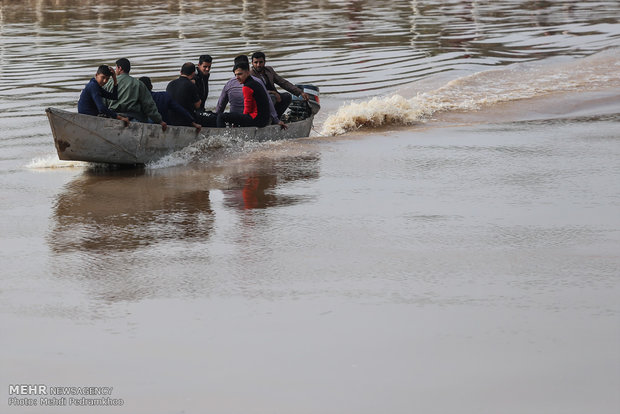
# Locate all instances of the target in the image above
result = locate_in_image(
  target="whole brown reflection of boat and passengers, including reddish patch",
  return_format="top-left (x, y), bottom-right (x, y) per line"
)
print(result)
top-left (48, 154), bottom-right (318, 254)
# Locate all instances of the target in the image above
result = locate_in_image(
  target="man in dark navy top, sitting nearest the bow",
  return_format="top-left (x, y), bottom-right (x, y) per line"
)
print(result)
top-left (78, 65), bottom-right (129, 125)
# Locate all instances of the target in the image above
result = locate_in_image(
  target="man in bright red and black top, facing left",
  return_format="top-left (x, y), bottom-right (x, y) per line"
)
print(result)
top-left (217, 62), bottom-right (271, 128)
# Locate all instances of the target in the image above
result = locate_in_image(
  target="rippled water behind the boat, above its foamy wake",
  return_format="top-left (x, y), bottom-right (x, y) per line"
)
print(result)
top-left (0, 0), bottom-right (620, 151)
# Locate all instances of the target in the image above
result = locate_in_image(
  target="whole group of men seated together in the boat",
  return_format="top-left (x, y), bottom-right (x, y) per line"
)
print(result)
top-left (78, 52), bottom-right (308, 131)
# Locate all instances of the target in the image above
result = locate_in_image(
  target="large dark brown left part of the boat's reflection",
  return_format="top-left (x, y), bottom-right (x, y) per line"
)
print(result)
top-left (49, 170), bottom-right (214, 252)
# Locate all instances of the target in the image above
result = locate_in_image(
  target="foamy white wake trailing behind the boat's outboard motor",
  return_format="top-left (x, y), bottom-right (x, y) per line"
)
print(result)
top-left (321, 48), bottom-right (620, 135)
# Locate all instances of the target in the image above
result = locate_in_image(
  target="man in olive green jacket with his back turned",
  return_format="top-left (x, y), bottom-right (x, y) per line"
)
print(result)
top-left (106, 58), bottom-right (167, 131)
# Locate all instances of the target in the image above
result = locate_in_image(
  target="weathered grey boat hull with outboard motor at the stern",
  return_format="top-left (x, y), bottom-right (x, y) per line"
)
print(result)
top-left (45, 85), bottom-right (320, 165)
